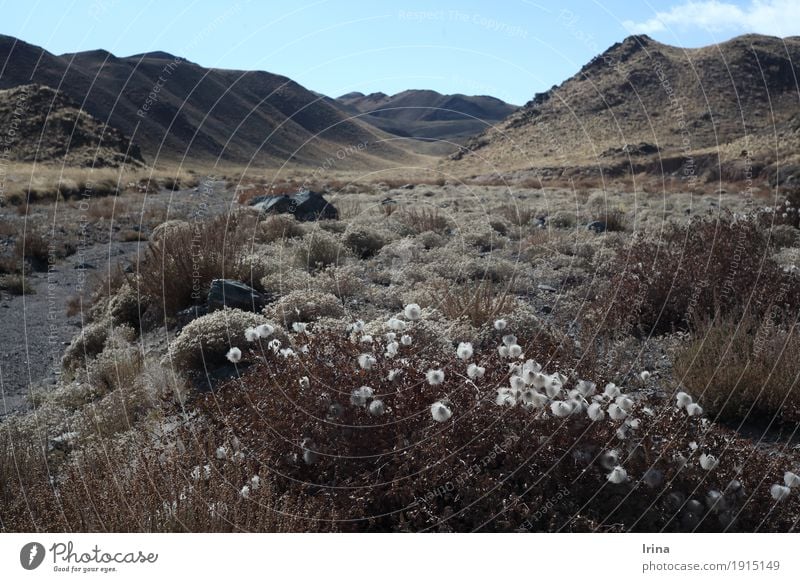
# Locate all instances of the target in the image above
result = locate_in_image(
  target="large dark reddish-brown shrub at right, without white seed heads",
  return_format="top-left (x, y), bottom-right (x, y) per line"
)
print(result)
top-left (588, 216), bottom-right (800, 335)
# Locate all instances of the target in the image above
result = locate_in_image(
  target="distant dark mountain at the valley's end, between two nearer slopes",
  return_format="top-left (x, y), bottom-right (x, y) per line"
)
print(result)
top-left (337, 90), bottom-right (517, 143)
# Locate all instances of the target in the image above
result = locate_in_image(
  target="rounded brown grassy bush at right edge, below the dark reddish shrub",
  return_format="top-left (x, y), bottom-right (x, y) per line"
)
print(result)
top-left (675, 314), bottom-right (800, 423)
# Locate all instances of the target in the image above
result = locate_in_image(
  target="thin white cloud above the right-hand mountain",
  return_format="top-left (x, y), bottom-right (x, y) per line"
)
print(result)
top-left (623, 0), bottom-right (800, 36)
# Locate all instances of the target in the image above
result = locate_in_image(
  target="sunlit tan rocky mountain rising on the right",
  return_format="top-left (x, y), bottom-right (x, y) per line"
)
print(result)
top-left (449, 34), bottom-right (800, 181)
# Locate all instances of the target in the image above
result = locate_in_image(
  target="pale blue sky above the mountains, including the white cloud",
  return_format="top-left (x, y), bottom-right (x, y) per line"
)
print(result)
top-left (0, 0), bottom-right (800, 105)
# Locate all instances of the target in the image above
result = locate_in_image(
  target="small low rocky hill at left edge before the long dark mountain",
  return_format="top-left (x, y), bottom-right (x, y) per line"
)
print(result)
top-left (0, 84), bottom-right (143, 167)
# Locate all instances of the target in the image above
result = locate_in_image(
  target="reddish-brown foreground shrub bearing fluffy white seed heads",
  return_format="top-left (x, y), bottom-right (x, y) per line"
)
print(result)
top-left (186, 326), bottom-right (800, 532)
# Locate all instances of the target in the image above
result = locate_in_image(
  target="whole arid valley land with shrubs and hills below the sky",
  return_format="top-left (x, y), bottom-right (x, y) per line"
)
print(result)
top-left (0, 30), bottom-right (800, 532)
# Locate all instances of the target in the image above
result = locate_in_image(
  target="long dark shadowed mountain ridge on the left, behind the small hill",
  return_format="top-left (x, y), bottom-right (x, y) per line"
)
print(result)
top-left (0, 36), bottom-right (418, 168)
